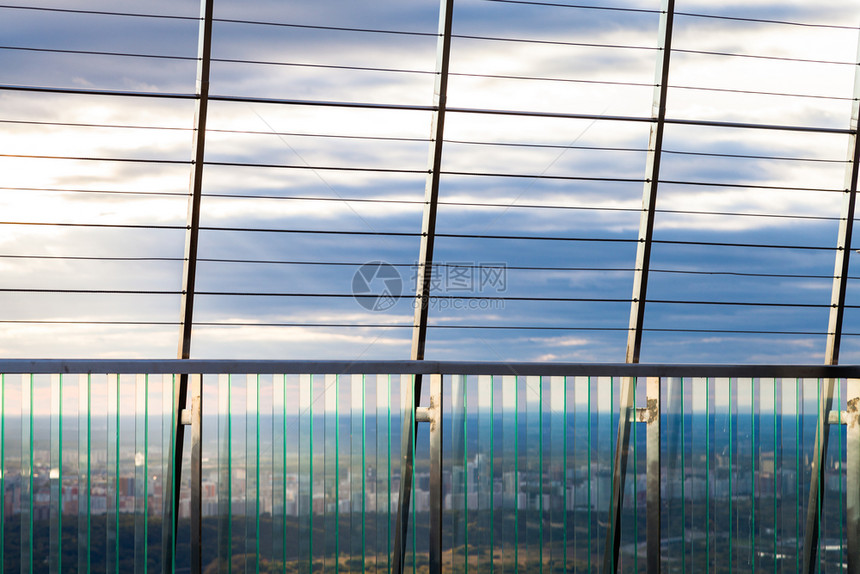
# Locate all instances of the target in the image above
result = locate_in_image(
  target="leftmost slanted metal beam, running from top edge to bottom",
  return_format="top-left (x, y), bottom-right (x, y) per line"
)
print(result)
top-left (162, 0), bottom-right (214, 574)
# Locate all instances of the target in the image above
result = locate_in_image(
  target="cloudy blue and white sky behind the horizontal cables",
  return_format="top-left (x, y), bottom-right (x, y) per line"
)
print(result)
top-left (0, 0), bottom-right (860, 363)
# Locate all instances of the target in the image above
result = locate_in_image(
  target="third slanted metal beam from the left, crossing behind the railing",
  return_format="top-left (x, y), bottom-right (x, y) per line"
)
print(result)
top-left (603, 0), bottom-right (675, 573)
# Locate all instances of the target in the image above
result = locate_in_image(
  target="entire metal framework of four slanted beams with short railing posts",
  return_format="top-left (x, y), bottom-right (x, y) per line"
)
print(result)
top-left (131, 0), bottom-right (860, 574)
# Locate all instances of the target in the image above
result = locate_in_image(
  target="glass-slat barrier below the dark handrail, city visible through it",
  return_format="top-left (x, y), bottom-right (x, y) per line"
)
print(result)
top-left (0, 374), bottom-right (848, 574)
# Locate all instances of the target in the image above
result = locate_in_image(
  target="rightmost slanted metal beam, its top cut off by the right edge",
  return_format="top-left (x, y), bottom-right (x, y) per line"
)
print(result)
top-left (803, 27), bottom-right (860, 573)
